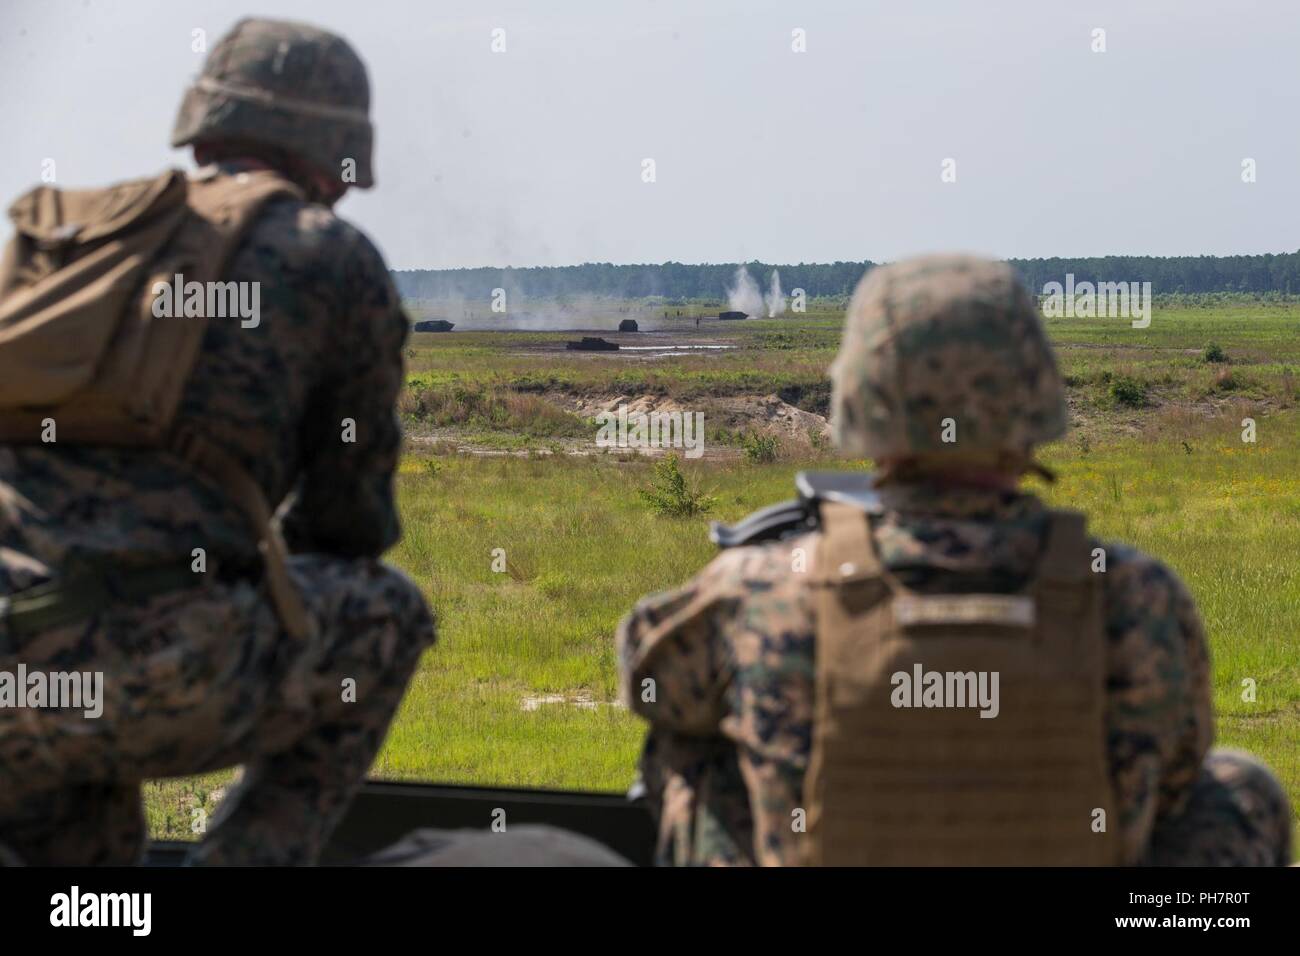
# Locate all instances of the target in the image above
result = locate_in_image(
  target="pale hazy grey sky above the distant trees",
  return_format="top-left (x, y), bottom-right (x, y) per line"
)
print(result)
top-left (0, 0), bottom-right (1300, 268)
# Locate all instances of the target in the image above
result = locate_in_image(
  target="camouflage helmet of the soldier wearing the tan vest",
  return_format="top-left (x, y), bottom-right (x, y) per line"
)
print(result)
top-left (831, 255), bottom-right (1066, 472)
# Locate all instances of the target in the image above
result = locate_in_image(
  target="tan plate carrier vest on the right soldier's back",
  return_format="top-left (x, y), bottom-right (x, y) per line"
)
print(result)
top-left (805, 502), bottom-right (1121, 866)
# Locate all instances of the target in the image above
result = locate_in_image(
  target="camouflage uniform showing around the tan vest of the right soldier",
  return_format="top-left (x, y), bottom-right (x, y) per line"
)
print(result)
top-left (618, 485), bottom-right (1290, 865)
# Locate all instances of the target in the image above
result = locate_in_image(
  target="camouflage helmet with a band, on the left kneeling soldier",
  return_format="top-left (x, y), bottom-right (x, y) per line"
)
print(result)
top-left (172, 18), bottom-right (374, 189)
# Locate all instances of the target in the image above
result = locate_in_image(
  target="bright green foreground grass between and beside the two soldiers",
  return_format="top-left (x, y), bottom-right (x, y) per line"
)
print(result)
top-left (378, 416), bottom-right (1300, 796)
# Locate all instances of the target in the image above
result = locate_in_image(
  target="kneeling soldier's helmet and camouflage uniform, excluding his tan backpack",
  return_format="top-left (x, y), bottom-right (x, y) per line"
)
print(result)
top-left (0, 20), bottom-right (434, 864)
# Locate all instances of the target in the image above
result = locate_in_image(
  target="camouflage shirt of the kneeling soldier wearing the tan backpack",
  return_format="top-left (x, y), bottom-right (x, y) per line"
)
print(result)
top-left (0, 164), bottom-right (408, 593)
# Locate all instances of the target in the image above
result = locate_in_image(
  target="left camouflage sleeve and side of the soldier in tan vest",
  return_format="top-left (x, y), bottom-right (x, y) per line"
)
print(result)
top-left (618, 536), bottom-right (814, 866)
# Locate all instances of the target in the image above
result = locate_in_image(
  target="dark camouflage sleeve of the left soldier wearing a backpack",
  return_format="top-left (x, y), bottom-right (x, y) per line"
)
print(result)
top-left (283, 233), bottom-right (411, 557)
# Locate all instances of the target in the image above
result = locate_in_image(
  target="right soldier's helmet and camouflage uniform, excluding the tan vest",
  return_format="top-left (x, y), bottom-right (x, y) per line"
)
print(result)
top-left (618, 258), bottom-right (1291, 865)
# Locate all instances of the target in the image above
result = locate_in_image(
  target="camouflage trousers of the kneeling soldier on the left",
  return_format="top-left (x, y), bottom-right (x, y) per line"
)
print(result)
top-left (0, 554), bottom-right (432, 865)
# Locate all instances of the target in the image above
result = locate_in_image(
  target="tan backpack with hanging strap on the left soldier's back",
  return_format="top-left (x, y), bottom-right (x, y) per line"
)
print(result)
top-left (0, 168), bottom-right (311, 639)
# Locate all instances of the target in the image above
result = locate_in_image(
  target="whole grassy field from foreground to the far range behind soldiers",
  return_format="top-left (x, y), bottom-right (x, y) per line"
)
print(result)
top-left (148, 304), bottom-right (1300, 853)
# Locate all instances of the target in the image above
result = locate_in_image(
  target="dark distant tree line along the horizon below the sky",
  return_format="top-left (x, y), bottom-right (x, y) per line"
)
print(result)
top-left (393, 251), bottom-right (1300, 300)
